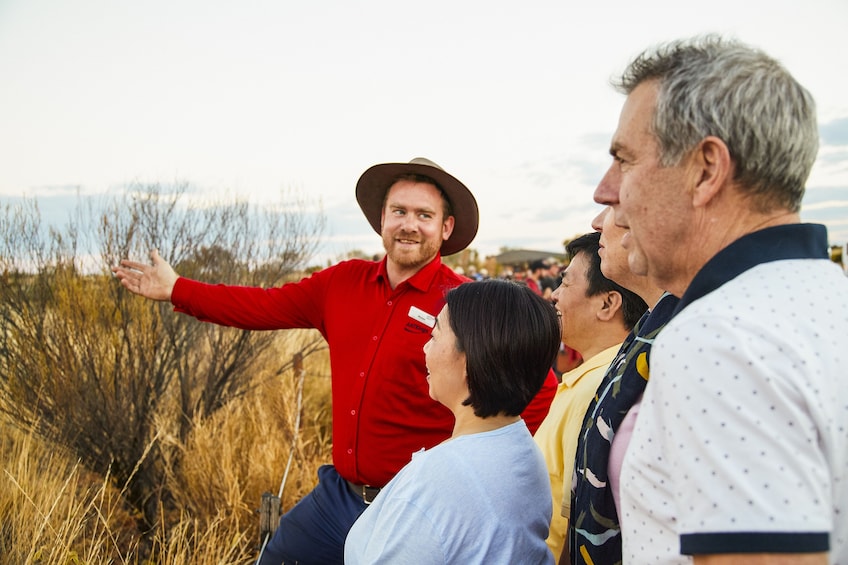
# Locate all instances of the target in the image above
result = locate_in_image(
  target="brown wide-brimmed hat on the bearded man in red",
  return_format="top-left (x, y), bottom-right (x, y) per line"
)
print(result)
top-left (356, 157), bottom-right (480, 255)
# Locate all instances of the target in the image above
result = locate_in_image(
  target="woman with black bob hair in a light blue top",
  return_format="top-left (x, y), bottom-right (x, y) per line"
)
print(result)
top-left (345, 279), bottom-right (560, 564)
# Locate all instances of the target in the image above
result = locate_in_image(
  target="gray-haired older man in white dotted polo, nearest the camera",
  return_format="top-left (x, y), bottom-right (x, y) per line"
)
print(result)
top-left (595, 36), bottom-right (848, 564)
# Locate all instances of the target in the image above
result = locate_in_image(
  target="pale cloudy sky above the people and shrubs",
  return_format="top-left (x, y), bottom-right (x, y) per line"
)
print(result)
top-left (0, 0), bottom-right (848, 257)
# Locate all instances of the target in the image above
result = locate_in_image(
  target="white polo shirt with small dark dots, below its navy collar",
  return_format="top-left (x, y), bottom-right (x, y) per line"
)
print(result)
top-left (621, 226), bottom-right (848, 564)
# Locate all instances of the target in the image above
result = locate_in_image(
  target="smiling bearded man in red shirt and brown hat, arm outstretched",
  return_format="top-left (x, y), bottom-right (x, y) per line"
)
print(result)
top-left (113, 158), bottom-right (557, 565)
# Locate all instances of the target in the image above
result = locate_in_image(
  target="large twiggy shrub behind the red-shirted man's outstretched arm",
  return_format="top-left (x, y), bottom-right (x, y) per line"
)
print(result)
top-left (0, 185), bottom-right (324, 528)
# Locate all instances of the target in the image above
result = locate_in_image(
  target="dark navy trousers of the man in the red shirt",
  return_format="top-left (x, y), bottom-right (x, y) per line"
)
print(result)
top-left (255, 465), bottom-right (366, 565)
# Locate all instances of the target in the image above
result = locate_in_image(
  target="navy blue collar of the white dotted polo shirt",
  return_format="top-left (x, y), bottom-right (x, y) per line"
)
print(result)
top-left (674, 224), bottom-right (828, 314)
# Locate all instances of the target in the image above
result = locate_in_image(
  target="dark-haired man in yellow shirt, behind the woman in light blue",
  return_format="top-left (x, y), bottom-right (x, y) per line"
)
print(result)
top-left (534, 232), bottom-right (648, 560)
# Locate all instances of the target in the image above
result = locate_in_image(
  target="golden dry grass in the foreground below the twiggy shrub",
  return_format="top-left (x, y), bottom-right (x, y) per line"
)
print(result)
top-left (0, 334), bottom-right (331, 565)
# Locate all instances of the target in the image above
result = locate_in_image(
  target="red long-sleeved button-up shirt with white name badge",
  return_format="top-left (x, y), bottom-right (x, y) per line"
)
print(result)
top-left (171, 256), bottom-right (557, 486)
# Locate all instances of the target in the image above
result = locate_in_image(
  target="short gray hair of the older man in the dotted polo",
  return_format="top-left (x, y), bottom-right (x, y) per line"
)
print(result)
top-left (613, 35), bottom-right (819, 212)
